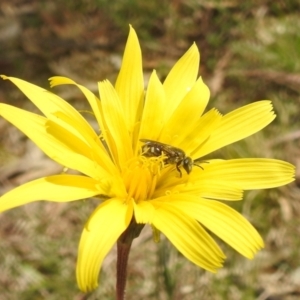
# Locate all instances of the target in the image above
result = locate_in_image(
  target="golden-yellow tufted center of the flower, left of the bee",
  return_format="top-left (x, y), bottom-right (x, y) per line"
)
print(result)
top-left (122, 156), bottom-right (163, 202)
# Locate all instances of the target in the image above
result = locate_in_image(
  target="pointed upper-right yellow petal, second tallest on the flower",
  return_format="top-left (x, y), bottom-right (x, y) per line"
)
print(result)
top-left (163, 44), bottom-right (200, 122)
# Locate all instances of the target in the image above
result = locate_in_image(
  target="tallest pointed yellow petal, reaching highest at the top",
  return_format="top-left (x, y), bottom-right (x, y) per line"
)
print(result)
top-left (115, 26), bottom-right (144, 135)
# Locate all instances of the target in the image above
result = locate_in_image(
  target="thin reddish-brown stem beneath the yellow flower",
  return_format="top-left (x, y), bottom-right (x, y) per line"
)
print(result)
top-left (116, 218), bottom-right (145, 300)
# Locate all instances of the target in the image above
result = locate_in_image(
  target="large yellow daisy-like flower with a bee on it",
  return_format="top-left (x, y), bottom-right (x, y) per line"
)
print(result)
top-left (0, 28), bottom-right (294, 291)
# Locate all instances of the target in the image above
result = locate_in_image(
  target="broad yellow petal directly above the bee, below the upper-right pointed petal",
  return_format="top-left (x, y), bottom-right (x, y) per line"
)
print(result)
top-left (160, 77), bottom-right (210, 145)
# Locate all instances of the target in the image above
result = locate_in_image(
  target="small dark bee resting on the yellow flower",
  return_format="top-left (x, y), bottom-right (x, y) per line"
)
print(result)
top-left (140, 139), bottom-right (203, 177)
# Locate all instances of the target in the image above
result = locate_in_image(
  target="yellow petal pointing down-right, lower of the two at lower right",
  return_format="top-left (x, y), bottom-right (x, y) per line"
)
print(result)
top-left (151, 200), bottom-right (225, 272)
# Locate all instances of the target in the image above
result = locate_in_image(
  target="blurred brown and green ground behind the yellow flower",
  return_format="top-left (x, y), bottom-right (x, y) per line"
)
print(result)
top-left (0, 0), bottom-right (300, 300)
